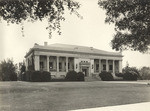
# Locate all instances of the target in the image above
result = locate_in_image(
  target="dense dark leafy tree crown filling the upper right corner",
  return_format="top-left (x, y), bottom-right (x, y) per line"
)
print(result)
top-left (98, 0), bottom-right (150, 53)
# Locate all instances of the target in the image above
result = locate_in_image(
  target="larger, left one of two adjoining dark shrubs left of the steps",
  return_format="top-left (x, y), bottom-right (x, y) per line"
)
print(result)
top-left (65, 71), bottom-right (77, 81)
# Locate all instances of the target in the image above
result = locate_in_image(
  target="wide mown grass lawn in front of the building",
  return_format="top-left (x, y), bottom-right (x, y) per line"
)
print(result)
top-left (0, 81), bottom-right (150, 111)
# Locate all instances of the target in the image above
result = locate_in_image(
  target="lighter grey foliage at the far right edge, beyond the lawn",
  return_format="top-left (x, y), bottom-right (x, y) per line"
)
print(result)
top-left (139, 67), bottom-right (150, 80)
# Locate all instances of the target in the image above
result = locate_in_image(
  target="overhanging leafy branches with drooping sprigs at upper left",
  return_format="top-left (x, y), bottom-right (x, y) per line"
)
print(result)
top-left (0, 0), bottom-right (80, 37)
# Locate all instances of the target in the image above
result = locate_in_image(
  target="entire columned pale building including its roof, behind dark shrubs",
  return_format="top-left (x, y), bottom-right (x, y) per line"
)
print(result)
top-left (25, 42), bottom-right (123, 78)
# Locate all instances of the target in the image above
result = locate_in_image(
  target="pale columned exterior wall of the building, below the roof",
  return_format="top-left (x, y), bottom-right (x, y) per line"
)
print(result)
top-left (26, 51), bottom-right (122, 78)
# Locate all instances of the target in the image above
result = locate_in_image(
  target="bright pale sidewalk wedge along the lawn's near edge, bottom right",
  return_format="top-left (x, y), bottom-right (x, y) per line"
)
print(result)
top-left (70, 102), bottom-right (150, 111)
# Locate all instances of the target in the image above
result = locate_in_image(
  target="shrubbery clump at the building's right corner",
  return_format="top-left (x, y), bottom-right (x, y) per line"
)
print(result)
top-left (123, 66), bottom-right (140, 80)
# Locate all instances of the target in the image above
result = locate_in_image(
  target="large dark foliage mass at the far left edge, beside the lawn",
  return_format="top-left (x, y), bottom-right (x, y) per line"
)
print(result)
top-left (0, 59), bottom-right (17, 81)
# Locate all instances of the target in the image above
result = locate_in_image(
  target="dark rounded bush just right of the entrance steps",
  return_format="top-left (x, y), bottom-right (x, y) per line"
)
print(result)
top-left (99, 72), bottom-right (114, 81)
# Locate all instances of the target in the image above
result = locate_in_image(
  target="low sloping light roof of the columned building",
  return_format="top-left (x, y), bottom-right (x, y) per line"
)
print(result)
top-left (25, 43), bottom-right (122, 57)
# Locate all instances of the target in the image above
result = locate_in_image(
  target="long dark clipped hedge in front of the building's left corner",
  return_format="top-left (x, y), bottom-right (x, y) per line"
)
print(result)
top-left (22, 71), bottom-right (51, 82)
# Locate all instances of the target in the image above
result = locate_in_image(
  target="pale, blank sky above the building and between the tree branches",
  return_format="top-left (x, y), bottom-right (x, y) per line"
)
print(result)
top-left (0, 0), bottom-right (150, 68)
